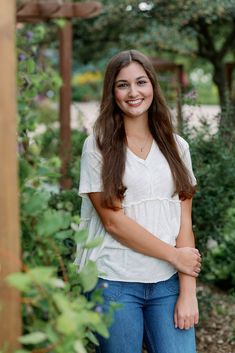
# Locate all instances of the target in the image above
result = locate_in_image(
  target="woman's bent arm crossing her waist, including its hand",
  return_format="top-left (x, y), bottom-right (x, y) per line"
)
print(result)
top-left (89, 192), bottom-right (201, 277)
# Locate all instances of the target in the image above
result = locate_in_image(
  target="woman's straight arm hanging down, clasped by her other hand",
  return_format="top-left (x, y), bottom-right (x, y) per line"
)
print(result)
top-left (174, 199), bottom-right (199, 329)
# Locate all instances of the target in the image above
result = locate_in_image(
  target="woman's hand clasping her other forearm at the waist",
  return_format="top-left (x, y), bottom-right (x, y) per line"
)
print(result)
top-left (172, 247), bottom-right (201, 277)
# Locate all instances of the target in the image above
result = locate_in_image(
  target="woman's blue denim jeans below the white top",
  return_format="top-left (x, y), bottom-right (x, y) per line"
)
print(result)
top-left (90, 274), bottom-right (196, 353)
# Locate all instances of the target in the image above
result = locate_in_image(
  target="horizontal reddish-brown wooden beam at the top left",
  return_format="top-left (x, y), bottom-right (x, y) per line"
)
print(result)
top-left (17, 1), bottom-right (102, 22)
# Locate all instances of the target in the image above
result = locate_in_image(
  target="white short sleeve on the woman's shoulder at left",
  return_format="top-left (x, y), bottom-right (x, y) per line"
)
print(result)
top-left (79, 136), bottom-right (103, 197)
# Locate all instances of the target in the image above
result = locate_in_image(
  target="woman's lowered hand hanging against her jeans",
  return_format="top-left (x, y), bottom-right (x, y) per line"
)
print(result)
top-left (174, 293), bottom-right (199, 330)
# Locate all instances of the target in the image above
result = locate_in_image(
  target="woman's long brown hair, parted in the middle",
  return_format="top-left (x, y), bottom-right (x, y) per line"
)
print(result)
top-left (94, 50), bottom-right (195, 209)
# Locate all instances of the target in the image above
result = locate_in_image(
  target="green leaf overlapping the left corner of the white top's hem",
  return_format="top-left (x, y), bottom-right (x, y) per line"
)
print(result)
top-left (79, 260), bottom-right (98, 292)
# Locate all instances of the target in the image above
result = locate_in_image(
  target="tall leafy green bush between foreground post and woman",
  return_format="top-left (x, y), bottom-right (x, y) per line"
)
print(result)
top-left (5, 24), bottom-right (114, 353)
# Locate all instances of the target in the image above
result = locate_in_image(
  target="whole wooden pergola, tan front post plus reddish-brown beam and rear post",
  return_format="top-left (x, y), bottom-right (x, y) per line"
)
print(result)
top-left (0, 0), bottom-right (101, 352)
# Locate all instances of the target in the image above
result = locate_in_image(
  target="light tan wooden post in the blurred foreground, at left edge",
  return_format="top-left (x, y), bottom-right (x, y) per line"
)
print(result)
top-left (0, 0), bottom-right (21, 352)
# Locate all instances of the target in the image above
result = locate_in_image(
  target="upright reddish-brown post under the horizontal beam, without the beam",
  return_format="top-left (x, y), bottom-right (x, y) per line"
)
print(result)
top-left (59, 21), bottom-right (72, 189)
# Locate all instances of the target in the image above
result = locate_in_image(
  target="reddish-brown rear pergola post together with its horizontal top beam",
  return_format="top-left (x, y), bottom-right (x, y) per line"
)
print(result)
top-left (17, 0), bottom-right (102, 189)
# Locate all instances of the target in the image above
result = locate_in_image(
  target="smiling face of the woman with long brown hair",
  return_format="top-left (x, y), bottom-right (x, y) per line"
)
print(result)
top-left (114, 62), bottom-right (153, 117)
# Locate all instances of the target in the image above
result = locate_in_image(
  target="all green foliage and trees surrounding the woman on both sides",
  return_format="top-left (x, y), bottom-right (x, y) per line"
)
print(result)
top-left (10, 0), bottom-right (235, 353)
